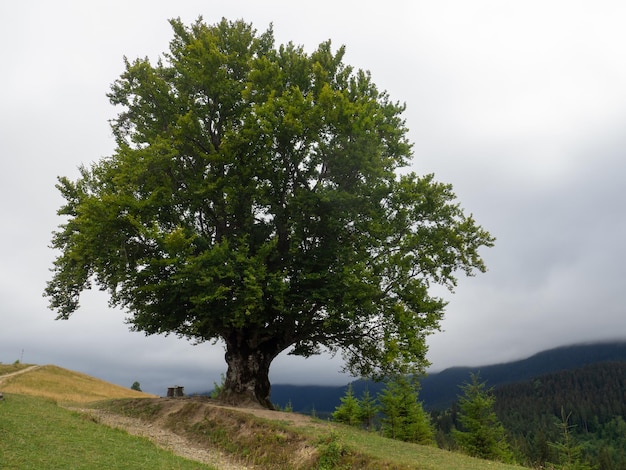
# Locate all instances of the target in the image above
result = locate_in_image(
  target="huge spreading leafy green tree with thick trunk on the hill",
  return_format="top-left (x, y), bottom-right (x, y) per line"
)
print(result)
top-left (45, 19), bottom-right (493, 407)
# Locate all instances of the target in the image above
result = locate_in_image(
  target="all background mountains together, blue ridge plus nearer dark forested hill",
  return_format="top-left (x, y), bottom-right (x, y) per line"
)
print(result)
top-left (272, 342), bottom-right (626, 470)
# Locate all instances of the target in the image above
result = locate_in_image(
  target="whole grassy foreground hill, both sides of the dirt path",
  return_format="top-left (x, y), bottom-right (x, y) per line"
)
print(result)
top-left (0, 366), bottom-right (521, 470)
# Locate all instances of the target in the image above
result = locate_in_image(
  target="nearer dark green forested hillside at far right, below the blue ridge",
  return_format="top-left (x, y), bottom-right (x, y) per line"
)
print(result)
top-left (433, 361), bottom-right (626, 470)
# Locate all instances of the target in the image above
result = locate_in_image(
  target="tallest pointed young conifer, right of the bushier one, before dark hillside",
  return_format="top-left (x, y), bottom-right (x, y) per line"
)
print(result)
top-left (452, 374), bottom-right (513, 462)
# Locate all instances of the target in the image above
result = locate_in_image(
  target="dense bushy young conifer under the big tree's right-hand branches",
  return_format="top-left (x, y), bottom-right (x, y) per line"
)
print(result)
top-left (379, 375), bottom-right (434, 444)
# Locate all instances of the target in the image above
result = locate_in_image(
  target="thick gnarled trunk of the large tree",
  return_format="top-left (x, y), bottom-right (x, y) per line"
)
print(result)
top-left (220, 333), bottom-right (282, 409)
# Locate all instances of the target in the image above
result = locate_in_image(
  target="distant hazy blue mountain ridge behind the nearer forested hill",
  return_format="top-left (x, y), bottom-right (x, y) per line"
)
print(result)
top-left (271, 341), bottom-right (626, 414)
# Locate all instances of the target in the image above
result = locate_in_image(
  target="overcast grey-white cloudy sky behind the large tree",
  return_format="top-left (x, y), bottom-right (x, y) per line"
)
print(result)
top-left (0, 0), bottom-right (626, 394)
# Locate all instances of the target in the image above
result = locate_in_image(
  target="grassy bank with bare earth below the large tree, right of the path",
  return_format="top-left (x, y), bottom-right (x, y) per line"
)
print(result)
top-left (94, 396), bottom-right (523, 470)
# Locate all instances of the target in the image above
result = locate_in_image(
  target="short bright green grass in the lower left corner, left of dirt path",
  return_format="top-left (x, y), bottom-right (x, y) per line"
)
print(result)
top-left (0, 394), bottom-right (211, 470)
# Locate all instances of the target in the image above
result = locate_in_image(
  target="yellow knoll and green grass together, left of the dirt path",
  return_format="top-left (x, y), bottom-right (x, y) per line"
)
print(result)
top-left (0, 364), bottom-right (214, 470)
